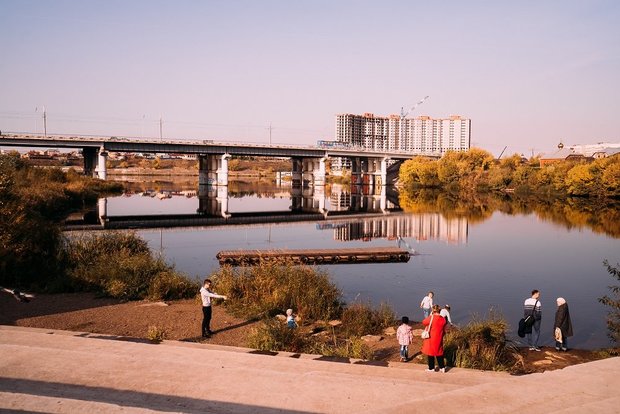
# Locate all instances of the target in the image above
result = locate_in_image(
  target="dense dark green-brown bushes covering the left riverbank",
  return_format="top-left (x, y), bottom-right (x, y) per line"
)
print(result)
top-left (0, 153), bottom-right (198, 299)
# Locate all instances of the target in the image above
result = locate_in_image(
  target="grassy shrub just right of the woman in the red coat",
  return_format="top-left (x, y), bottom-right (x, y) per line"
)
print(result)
top-left (444, 310), bottom-right (522, 371)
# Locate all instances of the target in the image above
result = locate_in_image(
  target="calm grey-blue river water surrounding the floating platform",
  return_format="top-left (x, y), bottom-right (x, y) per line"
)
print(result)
top-left (101, 183), bottom-right (620, 348)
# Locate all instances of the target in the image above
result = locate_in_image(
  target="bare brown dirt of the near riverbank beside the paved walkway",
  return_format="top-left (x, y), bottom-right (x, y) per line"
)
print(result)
top-left (0, 293), bottom-right (602, 373)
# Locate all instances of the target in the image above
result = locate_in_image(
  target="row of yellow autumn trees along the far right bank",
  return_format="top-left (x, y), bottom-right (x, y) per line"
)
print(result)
top-left (399, 148), bottom-right (620, 198)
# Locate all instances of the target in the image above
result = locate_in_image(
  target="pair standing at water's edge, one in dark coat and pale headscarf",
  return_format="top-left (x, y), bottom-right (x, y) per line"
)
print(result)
top-left (523, 289), bottom-right (573, 352)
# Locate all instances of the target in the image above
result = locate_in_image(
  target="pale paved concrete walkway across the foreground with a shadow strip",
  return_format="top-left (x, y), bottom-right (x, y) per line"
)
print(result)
top-left (0, 326), bottom-right (620, 414)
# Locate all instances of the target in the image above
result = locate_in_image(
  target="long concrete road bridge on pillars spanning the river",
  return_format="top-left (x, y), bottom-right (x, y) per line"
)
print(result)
top-left (0, 133), bottom-right (440, 186)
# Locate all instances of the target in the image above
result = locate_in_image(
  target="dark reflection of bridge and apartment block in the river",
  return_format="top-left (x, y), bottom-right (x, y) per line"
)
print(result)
top-left (65, 186), bottom-right (468, 244)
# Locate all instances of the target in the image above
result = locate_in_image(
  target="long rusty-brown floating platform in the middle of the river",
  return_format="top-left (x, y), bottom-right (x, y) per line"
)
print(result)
top-left (216, 247), bottom-right (410, 266)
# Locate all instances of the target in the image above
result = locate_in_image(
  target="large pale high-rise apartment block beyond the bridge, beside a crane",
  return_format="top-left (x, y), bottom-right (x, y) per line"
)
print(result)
top-left (336, 113), bottom-right (471, 155)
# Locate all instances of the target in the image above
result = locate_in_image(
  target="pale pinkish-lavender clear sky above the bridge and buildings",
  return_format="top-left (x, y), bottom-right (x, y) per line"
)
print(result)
top-left (0, 0), bottom-right (620, 156)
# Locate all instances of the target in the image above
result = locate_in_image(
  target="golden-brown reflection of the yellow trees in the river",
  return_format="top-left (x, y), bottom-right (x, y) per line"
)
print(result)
top-left (400, 190), bottom-right (620, 238)
